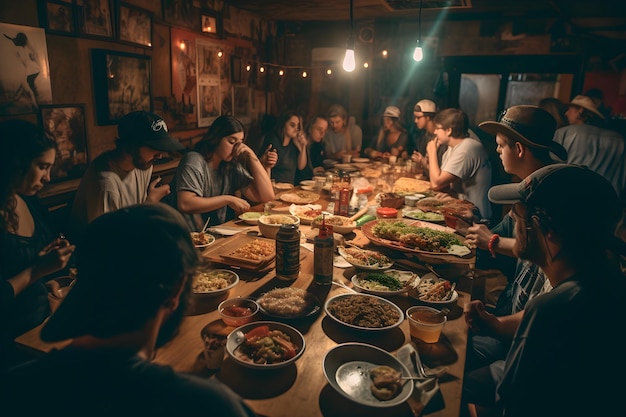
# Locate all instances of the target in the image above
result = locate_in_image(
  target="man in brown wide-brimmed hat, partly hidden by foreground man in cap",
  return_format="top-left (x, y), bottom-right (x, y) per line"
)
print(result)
top-left (463, 105), bottom-right (567, 416)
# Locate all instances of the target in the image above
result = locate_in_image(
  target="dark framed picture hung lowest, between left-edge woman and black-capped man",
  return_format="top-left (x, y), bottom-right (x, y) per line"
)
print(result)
top-left (39, 104), bottom-right (88, 182)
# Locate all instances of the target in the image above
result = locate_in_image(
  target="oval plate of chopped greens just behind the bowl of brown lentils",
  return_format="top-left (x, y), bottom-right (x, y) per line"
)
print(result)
top-left (352, 269), bottom-right (419, 297)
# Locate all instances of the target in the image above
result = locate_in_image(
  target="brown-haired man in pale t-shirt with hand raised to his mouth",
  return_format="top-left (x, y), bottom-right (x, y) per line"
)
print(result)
top-left (426, 108), bottom-right (491, 219)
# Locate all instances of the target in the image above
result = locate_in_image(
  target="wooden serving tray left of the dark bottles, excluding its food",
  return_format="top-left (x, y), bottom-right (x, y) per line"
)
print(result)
top-left (202, 234), bottom-right (276, 270)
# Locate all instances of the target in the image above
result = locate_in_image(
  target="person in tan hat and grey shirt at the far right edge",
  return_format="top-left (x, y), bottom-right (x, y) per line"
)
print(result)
top-left (554, 95), bottom-right (626, 199)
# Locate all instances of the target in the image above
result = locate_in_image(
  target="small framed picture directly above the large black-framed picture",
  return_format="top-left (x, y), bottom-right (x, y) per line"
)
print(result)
top-left (117, 3), bottom-right (152, 48)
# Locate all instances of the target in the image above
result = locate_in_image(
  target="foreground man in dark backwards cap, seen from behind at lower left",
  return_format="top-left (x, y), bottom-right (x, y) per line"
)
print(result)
top-left (0, 203), bottom-right (254, 417)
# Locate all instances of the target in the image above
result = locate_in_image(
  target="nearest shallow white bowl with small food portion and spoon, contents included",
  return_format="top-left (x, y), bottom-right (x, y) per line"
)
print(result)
top-left (322, 343), bottom-right (414, 408)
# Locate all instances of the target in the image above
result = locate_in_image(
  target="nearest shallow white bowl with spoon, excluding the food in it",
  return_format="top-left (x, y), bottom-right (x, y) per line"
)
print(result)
top-left (322, 343), bottom-right (414, 408)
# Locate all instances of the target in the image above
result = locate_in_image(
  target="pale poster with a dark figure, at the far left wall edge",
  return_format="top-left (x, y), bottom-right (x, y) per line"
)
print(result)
top-left (0, 23), bottom-right (52, 116)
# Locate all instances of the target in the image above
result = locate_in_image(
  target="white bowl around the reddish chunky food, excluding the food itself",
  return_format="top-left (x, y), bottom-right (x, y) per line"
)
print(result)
top-left (226, 321), bottom-right (306, 370)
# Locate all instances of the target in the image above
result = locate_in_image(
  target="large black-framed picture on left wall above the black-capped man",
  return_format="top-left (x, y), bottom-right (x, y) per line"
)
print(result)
top-left (91, 49), bottom-right (152, 125)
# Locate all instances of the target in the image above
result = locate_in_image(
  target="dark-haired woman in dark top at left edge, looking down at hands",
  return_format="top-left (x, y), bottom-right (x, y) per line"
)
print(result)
top-left (0, 120), bottom-right (74, 365)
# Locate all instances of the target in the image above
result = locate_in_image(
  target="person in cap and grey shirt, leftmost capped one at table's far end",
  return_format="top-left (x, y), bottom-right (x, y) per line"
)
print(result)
top-left (324, 104), bottom-right (363, 161)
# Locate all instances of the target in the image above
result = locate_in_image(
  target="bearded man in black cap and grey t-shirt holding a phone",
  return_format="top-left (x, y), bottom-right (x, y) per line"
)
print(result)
top-left (71, 111), bottom-right (184, 239)
